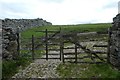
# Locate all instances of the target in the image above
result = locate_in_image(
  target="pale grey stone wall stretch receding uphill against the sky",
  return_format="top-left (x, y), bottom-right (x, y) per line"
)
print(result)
top-left (2, 18), bottom-right (52, 31)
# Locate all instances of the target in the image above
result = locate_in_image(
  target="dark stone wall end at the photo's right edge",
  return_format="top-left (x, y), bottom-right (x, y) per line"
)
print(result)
top-left (110, 14), bottom-right (120, 70)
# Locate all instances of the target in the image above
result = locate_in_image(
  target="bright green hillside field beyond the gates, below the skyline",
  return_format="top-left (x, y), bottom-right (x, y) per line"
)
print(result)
top-left (21, 23), bottom-right (111, 38)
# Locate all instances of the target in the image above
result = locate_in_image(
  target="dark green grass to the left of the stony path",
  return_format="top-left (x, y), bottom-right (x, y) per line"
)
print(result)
top-left (2, 57), bottom-right (32, 79)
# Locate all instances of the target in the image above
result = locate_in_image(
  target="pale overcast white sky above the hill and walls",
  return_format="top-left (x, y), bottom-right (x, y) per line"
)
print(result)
top-left (0, 0), bottom-right (119, 25)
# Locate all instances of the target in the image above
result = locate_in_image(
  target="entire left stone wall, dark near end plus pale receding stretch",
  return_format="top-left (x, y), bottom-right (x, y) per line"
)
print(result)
top-left (0, 18), bottom-right (52, 60)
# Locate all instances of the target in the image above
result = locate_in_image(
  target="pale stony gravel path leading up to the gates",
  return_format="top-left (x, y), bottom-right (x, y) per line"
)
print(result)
top-left (12, 59), bottom-right (61, 78)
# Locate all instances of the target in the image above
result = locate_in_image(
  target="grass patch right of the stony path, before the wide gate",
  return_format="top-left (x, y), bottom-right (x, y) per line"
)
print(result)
top-left (57, 63), bottom-right (120, 78)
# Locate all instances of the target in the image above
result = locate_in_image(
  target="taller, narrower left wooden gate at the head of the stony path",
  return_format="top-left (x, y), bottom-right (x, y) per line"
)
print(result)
top-left (34, 28), bottom-right (61, 60)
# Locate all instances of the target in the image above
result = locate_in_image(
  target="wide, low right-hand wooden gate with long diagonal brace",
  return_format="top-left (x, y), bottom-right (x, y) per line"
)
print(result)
top-left (61, 33), bottom-right (107, 64)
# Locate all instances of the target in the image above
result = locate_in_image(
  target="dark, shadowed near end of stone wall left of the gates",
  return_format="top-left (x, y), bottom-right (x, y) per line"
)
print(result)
top-left (2, 28), bottom-right (18, 60)
